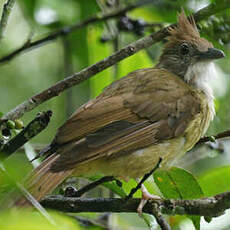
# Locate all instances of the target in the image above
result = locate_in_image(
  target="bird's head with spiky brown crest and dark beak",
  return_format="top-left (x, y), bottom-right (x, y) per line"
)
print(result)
top-left (158, 11), bottom-right (224, 83)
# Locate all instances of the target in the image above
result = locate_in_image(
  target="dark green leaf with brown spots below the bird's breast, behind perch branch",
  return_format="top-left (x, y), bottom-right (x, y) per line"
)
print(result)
top-left (154, 167), bottom-right (204, 230)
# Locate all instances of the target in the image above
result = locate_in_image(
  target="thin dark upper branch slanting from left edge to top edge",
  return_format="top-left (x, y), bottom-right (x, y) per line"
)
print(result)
top-left (0, 0), bottom-right (152, 63)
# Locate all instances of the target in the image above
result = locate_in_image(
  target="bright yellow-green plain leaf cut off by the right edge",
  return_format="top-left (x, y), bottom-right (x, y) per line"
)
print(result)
top-left (198, 166), bottom-right (230, 196)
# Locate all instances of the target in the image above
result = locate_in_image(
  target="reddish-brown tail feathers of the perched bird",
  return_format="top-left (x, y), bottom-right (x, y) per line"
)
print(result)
top-left (15, 154), bottom-right (73, 206)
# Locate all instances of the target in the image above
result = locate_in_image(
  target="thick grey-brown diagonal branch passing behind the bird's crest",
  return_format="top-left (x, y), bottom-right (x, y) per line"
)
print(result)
top-left (2, 1), bottom-right (230, 120)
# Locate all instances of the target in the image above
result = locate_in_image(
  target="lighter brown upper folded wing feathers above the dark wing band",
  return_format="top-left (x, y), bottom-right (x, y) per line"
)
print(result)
top-left (55, 97), bottom-right (139, 144)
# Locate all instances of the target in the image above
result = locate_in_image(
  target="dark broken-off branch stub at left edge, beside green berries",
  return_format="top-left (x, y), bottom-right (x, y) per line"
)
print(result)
top-left (1, 110), bottom-right (52, 159)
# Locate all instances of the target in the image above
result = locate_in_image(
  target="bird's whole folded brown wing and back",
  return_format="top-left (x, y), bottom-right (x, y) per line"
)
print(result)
top-left (52, 69), bottom-right (200, 171)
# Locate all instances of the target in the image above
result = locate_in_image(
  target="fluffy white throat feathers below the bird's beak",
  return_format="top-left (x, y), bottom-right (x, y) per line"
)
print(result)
top-left (184, 61), bottom-right (217, 119)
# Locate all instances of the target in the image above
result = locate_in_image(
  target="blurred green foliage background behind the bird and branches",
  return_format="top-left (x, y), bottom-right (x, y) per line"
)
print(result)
top-left (0, 0), bottom-right (230, 230)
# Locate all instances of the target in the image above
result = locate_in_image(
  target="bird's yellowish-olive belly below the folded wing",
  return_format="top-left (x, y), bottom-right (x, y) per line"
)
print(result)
top-left (75, 137), bottom-right (185, 181)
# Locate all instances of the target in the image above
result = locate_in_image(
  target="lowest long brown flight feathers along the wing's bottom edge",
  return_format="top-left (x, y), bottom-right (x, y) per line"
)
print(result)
top-left (51, 122), bottom-right (160, 172)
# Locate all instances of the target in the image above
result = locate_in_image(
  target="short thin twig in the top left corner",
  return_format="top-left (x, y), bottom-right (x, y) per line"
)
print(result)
top-left (0, 0), bottom-right (16, 40)
